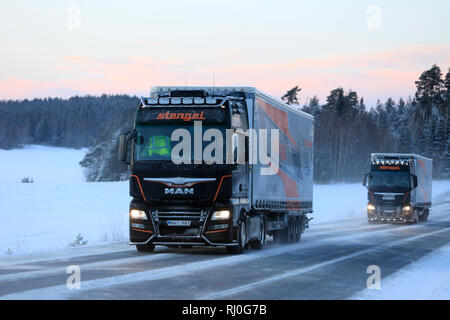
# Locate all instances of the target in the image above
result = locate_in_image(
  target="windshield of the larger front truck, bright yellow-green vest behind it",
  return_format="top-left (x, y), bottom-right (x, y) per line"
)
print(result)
top-left (134, 123), bottom-right (226, 162)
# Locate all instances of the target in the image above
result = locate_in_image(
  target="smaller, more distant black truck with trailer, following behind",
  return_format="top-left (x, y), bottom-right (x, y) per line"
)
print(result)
top-left (363, 153), bottom-right (433, 224)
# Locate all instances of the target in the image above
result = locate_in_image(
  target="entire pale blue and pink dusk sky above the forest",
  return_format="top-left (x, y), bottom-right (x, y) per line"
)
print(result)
top-left (0, 0), bottom-right (450, 105)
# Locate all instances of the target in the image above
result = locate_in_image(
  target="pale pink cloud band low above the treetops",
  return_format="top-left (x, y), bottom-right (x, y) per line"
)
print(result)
top-left (0, 46), bottom-right (450, 103)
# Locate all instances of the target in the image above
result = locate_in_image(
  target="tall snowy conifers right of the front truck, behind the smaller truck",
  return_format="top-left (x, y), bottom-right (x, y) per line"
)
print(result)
top-left (282, 65), bottom-right (450, 183)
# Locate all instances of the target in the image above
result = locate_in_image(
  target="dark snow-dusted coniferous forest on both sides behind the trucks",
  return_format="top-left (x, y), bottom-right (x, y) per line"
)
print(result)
top-left (0, 65), bottom-right (450, 183)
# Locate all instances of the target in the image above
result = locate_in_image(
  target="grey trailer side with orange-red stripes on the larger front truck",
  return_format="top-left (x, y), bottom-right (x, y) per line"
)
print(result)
top-left (252, 93), bottom-right (314, 212)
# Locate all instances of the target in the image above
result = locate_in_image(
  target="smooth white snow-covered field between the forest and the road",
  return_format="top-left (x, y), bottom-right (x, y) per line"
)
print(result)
top-left (0, 146), bottom-right (450, 256)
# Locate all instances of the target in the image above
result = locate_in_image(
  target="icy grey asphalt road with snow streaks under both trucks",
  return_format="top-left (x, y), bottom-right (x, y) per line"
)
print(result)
top-left (0, 194), bottom-right (450, 300)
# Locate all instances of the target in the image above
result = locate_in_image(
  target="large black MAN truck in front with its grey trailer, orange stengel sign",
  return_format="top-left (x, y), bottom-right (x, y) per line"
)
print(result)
top-left (119, 87), bottom-right (314, 253)
